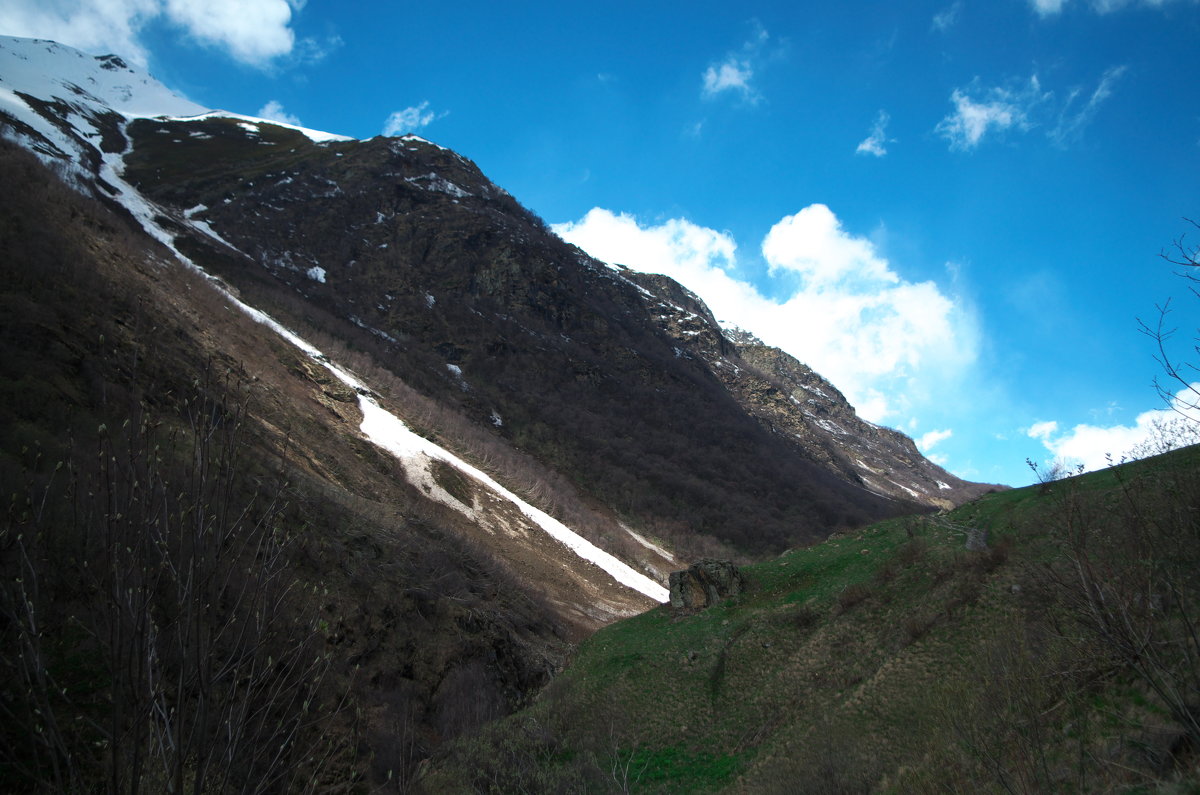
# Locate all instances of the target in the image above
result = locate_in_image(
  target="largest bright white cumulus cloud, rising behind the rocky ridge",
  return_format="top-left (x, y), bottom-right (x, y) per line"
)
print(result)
top-left (554, 204), bottom-right (978, 422)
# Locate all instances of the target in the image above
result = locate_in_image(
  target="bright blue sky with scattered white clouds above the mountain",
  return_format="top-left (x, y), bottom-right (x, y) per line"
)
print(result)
top-left (0, 0), bottom-right (1200, 484)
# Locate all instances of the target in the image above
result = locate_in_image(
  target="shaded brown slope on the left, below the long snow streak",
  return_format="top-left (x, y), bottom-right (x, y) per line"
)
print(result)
top-left (0, 138), bottom-right (580, 791)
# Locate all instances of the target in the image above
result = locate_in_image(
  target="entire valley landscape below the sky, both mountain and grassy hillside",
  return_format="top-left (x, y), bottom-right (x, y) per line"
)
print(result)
top-left (0, 37), bottom-right (1200, 793)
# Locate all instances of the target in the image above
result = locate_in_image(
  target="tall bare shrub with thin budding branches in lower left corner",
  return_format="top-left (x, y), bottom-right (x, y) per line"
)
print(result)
top-left (0, 386), bottom-right (338, 793)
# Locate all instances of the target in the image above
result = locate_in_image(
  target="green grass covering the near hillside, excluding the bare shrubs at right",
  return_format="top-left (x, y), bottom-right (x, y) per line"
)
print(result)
top-left (432, 449), bottom-right (1200, 793)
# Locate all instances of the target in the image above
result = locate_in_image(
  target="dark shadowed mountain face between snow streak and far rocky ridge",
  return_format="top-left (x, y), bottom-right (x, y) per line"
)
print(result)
top-left (114, 119), bottom-right (911, 552)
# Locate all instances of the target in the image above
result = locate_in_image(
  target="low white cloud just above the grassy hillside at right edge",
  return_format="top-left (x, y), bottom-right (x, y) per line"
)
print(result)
top-left (1026, 384), bottom-right (1200, 470)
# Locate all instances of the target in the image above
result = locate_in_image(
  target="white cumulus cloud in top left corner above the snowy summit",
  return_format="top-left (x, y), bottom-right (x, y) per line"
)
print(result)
top-left (0, 0), bottom-right (302, 66)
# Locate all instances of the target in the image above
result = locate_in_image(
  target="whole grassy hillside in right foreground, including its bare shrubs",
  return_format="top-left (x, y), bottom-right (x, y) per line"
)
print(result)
top-left (426, 448), bottom-right (1200, 793)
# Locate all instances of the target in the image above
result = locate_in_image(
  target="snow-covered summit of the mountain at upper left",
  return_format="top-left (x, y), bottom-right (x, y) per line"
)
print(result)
top-left (0, 36), bottom-right (352, 142)
